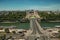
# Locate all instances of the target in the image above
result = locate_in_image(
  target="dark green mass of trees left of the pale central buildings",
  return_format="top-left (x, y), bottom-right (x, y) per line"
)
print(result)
top-left (0, 11), bottom-right (26, 21)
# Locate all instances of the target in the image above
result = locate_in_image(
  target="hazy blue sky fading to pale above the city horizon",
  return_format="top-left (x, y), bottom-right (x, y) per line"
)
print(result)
top-left (0, 0), bottom-right (60, 10)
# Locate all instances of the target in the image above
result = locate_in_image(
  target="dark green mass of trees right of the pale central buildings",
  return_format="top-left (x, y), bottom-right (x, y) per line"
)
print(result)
top-left (39, 12), bottom-right (60, 20)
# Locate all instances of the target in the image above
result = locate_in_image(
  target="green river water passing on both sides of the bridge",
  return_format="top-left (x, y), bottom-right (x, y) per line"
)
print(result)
top-left (0, 22), bottom-right (60, 29)
